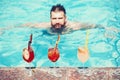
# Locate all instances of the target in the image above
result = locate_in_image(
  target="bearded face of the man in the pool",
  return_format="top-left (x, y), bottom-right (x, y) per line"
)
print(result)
top-left (51, 11), bottom-right (66, 29)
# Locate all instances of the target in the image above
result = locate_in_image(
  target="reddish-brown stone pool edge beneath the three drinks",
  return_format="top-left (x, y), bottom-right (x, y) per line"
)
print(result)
top-left (0, 67), bottom-right (120, 80)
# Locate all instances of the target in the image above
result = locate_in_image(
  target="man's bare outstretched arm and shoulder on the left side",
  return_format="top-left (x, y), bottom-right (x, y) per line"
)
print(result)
top-left (22, 22), bottom-right (51, 28)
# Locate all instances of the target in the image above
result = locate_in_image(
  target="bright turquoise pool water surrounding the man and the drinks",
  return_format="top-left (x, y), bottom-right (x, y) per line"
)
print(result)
top-left (0, 0), bottom-right (120, 67)
